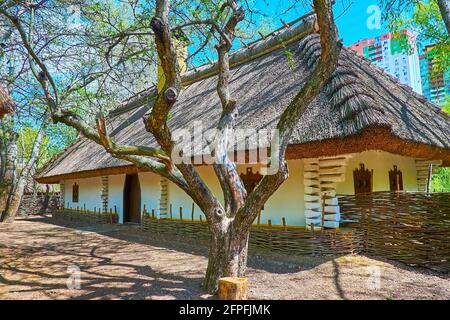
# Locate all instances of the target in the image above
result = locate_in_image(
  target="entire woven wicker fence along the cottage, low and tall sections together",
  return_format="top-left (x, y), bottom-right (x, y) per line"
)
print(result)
top-left (54, 192), bottom-right (450, 272)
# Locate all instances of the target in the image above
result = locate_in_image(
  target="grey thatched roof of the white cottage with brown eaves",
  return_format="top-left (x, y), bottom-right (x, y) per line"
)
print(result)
top-left (37, 24), bottom-right (450, 183)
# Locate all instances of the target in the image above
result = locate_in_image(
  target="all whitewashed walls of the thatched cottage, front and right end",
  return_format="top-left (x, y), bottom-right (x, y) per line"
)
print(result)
top-left (59, 151), bottom-right (417, 226)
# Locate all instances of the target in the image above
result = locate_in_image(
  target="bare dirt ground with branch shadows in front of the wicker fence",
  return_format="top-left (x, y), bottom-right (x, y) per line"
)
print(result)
top-left (0, 218), bottom-right (450, 300)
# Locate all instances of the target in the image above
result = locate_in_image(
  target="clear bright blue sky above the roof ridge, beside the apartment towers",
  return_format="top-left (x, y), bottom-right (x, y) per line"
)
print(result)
top-left (256, 0), bottom-right (388, 45)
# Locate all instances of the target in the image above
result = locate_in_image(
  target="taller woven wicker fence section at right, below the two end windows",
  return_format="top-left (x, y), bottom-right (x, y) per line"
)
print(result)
top-left (339, 192), bottom-right (450, 271)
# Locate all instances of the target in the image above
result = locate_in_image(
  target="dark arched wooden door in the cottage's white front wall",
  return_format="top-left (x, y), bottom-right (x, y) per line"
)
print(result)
top-left (123, 174), bottom-right (141, 223)
